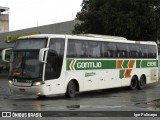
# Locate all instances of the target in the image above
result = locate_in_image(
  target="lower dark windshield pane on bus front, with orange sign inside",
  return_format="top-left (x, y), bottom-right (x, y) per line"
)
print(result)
top-left (10, 50), bottom-right (43, 79)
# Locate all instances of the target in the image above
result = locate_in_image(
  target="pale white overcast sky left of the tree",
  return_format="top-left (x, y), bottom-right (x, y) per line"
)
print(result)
top-left (0, 0), bottom-right (83, 31)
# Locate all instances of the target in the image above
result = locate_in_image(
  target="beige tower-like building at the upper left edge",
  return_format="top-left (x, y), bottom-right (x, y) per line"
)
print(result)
top-left (0, 6), bottom-right (9, 33)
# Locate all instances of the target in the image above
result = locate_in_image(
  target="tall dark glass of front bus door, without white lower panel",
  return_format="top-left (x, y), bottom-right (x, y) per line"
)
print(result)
top-left (45, 38), bottom-right (64, 80)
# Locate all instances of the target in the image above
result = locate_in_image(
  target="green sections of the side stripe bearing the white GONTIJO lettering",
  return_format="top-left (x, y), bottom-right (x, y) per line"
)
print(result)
top-left (66, 59), bottom-right (158, 70)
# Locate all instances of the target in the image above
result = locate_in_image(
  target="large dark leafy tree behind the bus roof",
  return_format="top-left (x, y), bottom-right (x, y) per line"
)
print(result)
top-left (73, 0), bottom-right (160, 41)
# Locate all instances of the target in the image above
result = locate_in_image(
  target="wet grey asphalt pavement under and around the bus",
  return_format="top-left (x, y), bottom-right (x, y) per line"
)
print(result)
top-left (0, 77), bottom-right (160, 120)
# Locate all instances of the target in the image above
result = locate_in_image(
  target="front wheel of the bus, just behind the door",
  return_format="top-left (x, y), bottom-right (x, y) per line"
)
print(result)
top-left (65, 81), bottom-right (76, 98)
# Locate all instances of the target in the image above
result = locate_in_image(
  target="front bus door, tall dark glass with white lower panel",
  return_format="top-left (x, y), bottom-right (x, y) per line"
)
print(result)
top-left (45, 38), bottom-right (65, 93)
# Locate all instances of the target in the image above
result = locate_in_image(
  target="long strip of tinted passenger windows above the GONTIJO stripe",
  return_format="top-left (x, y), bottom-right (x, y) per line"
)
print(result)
top-left (67, 40), bottom-right (157, 58)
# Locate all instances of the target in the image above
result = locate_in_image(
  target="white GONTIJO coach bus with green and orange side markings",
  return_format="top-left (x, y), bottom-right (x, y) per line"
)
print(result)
top-left (2, 34), bottom-right (158, 98)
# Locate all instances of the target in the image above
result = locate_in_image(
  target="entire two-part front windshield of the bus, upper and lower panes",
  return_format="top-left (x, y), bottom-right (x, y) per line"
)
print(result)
top-left (10, 39), bottom-right (46, 79)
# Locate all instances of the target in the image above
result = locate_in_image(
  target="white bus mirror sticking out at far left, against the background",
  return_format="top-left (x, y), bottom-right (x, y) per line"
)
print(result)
top-left (2, 48), bottom-right (13, 62)
